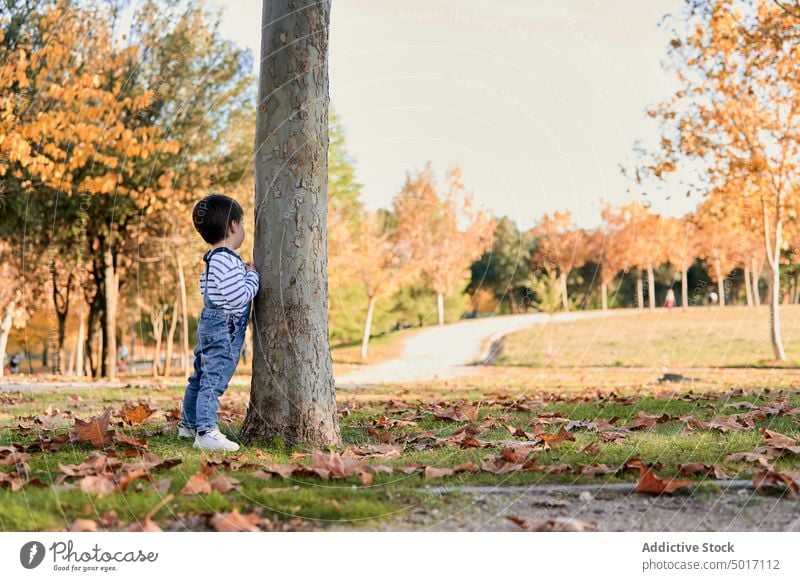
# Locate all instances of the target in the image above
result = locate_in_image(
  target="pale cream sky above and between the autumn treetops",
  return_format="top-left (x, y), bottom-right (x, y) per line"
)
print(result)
top-left (212, 0), bottom-right (696, 228)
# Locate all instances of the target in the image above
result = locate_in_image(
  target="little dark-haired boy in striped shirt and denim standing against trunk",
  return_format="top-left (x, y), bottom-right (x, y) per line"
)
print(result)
top-left (178, 194), bottom-right (259, 451)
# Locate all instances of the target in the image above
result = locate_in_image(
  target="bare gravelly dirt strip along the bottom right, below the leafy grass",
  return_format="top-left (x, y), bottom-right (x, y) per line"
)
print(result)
top-left (325, 487), bottom-right (800, 532)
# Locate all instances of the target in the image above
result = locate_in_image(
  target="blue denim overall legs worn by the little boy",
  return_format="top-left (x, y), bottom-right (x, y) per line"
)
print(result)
top-left (181, 305), bottom-right (250, 432)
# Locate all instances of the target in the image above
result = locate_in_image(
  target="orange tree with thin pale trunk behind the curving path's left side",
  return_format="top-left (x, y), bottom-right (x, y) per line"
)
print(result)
top-left (394, 162), bottom-right (496, 325)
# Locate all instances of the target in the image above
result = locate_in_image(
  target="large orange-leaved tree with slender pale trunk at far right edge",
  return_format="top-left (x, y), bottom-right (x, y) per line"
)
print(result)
top-left (650, 0), bottom-right (800, 361)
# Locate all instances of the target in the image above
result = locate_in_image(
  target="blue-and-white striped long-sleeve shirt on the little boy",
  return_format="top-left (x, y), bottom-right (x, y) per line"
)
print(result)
top-left (200, 247), bottom-right (259, 313)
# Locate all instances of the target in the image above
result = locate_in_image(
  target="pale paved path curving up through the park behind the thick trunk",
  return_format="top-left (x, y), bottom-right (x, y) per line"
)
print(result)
top-left (336, 309), bottom-right (643, 389)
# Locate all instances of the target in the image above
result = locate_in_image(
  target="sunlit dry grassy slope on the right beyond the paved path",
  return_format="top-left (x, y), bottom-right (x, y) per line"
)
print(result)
top-left (494, 305), bottom-right (800, 368)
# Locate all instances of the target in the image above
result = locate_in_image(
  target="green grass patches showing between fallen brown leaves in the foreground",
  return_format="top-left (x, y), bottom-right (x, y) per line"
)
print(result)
top-left (0, 380), bottom-right (800, 531)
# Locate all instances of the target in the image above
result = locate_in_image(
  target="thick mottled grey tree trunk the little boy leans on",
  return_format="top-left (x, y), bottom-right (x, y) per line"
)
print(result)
top-left (241, 0), bottom-right (341, 445)
